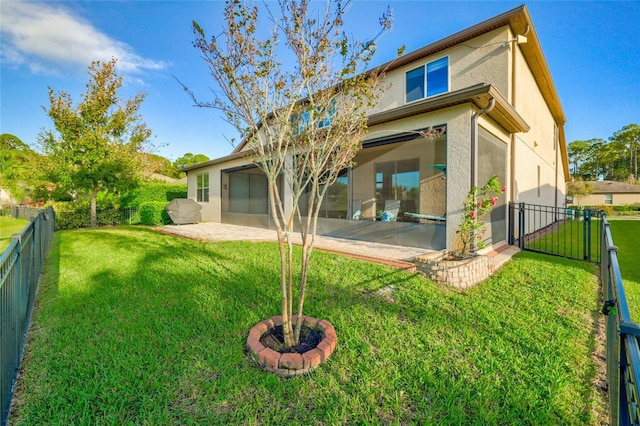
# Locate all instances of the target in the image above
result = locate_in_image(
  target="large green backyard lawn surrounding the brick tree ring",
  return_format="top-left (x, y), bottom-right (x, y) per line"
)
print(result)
top-left (11, 227), bottom-right (606, 425)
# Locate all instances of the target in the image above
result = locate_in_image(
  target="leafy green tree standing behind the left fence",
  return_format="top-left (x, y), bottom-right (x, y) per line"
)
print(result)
top-left (40, 59), bottom-right (151, 227)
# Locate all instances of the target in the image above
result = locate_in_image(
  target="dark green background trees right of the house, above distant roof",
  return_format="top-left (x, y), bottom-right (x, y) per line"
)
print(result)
top-left (567, 124), bottom-right (640, 184)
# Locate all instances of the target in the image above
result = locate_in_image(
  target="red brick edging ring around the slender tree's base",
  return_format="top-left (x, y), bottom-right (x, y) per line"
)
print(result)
top-left (247, 315), bottom-right (338, 377)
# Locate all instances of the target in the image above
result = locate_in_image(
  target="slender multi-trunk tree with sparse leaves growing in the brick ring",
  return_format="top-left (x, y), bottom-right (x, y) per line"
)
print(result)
top-left (185, 0), bottom-right (390, 347)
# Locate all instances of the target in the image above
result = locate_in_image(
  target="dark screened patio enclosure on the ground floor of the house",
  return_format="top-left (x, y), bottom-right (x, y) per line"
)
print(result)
top-left (221, 132), bottom-right (447, 249)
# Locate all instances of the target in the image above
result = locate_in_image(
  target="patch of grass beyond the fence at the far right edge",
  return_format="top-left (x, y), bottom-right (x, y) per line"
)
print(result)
top-left (609, 219), bottom-right (640, 322)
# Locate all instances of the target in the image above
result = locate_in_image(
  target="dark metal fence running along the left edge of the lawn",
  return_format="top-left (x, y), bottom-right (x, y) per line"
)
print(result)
top-left (0, 207), bottom-right (55, 425)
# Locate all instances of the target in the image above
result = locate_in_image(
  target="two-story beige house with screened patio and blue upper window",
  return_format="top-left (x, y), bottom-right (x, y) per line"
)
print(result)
top-left (185, 5), bottom-right (569, 250)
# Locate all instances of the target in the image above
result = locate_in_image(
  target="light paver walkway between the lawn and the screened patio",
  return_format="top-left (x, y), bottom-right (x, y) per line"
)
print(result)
top-left (158, 222), bottom-right (518, 270)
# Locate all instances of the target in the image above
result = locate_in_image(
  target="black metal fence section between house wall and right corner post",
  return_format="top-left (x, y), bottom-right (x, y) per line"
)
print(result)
top-left (509, 203), bottom-right (603, 262)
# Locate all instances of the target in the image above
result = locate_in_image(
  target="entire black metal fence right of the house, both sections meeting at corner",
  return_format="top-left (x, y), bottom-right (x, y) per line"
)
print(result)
top-left (509, 203), bottom-right (640, 425)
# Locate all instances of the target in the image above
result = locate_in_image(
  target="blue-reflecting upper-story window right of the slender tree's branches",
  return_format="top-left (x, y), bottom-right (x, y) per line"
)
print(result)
top-left (406, 56), bottom-right (449, 102)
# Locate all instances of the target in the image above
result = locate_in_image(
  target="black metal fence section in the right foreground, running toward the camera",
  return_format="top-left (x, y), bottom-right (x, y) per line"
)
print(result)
top-left (600, 216), bottom-right (640, 425)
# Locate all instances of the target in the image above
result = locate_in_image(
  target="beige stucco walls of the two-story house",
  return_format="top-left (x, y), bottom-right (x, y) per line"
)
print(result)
top-left (188, 21), bottom-right (568, 249)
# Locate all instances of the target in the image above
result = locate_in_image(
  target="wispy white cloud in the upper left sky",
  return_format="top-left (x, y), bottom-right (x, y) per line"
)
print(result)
top-left (0, 1), bottom-right (167, 73)
